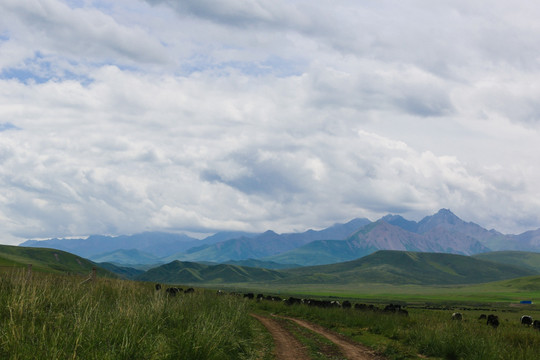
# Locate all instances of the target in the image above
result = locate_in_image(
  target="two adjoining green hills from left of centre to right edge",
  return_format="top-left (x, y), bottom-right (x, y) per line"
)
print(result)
top-left (136, 250), bottom-right (537, 286)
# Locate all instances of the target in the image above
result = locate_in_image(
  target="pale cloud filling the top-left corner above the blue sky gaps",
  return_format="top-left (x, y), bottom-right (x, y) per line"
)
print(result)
top-left (0, 0), bottom-right (168, 75)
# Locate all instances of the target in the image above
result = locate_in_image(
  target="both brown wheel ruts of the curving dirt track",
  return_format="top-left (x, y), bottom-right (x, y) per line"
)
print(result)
top-left (252, 314), bottom-right (383, 360)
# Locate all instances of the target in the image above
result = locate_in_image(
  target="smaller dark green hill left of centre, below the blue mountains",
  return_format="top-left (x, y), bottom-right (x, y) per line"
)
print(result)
top-left (136, 260), bottom-right (286, 284)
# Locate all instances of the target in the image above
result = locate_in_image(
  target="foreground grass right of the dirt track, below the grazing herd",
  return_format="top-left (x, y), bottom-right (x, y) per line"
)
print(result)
top-left (252, 301), bottom-right (540, 360)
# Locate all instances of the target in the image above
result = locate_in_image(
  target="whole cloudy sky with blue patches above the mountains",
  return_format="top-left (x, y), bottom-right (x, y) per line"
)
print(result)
top-left (0, 0), bottom-right (540, 244)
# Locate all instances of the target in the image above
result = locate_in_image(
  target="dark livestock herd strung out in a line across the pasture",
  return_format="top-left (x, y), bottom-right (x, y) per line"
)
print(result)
top-left (155, 284), bottom-right (540, 330)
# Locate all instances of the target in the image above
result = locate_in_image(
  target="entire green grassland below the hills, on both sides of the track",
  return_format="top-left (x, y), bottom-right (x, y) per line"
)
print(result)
top-left (0, 271), bottom-right (540, 360)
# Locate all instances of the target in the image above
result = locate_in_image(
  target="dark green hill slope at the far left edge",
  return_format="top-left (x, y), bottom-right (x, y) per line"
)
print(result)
top-left (0, 245), bottom-right (117, 277)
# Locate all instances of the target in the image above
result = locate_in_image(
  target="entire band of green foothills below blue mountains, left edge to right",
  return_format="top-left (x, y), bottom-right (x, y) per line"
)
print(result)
top-left (4, 239), bottom-right (540, 291)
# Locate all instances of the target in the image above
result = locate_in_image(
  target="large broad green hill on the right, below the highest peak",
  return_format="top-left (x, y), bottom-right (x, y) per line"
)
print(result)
top-left (279, 250), bottom-right (535, 285)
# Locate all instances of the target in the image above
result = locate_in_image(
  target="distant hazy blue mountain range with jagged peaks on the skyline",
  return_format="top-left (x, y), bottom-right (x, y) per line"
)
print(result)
top-left (21, 209), bottom-right (540, 268)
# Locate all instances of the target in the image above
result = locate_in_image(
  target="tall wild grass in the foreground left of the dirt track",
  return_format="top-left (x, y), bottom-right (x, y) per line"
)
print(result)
top-left (0, 272), bottom-right (258, 360)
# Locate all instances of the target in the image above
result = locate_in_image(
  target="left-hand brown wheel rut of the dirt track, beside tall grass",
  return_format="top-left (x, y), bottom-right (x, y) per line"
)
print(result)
top-left (251, 314), bottom-right (310, 360)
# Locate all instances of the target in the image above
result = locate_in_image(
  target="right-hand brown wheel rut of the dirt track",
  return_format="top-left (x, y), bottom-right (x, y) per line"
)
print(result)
top-left (274, 315), bottom-right (384, 360)
